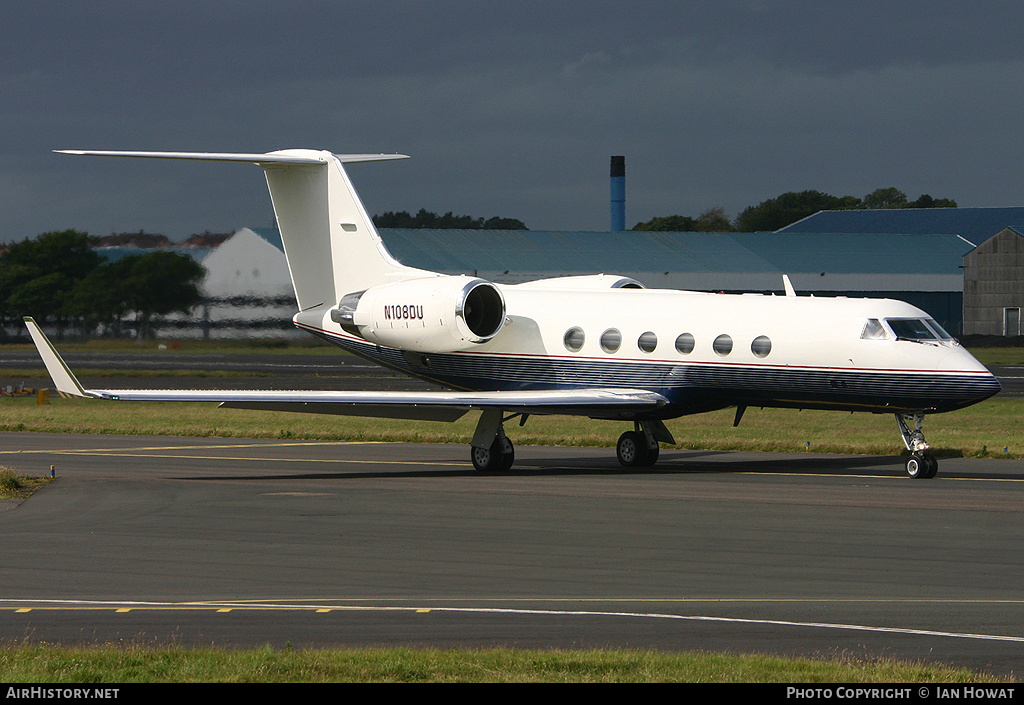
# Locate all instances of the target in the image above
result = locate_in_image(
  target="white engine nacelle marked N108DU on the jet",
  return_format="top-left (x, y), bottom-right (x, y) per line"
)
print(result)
top-left (331, 276), bottom-right (505, 353)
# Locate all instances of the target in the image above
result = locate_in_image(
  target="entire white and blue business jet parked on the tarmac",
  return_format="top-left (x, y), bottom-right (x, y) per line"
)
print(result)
top-left (26, 150), bottom-right (999, 478)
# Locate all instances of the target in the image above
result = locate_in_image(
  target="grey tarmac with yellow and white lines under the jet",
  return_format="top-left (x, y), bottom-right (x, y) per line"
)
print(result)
top-left (0, 433), bottom-right (1024, 675)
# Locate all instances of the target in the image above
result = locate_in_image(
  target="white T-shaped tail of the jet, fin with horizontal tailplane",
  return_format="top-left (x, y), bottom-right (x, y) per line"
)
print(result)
top-left (59, 150), bottom-right (431, 310)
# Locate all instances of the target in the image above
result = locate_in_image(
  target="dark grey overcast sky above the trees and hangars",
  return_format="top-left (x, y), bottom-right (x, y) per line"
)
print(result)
top-left (0, 0), bottom-right (1024, 240)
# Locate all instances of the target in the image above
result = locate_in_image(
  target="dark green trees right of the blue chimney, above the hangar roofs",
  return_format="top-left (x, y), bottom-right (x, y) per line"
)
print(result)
top-left (633, 186), bottom-right (956, 233)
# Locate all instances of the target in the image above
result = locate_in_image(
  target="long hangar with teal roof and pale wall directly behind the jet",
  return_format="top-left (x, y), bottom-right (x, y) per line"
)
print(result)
top-left (380, 229), bottom-right (971, 335)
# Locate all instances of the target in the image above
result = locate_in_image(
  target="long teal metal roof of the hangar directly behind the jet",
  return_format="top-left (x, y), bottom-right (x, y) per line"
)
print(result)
top-left (380, 229), bottom-right (972, 274)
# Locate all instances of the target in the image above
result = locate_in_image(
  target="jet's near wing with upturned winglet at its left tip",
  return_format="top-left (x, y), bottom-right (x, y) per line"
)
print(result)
top-left (25, 318), bottom-right (668, 421)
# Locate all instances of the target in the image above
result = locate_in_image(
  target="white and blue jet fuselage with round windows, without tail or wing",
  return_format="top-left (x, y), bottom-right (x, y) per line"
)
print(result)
top-left (295, 285), bottom-right (999, 418)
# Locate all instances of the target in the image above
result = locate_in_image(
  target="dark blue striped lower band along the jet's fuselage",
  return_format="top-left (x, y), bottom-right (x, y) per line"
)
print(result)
top-left (303, 326), bottom-right (1000, 418)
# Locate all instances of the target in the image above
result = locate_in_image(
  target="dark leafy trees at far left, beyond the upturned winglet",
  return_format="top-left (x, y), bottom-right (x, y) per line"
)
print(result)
top-left (0, 230), bottom-right (206, 338)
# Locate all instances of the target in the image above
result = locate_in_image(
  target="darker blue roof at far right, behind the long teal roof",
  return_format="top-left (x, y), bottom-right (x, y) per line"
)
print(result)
top-left (778, 208), bottom-right (1024, 245)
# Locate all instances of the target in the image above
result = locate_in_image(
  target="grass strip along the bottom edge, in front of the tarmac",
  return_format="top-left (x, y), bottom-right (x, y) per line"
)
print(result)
top-left (0, 644), bottom-right (1007, 683)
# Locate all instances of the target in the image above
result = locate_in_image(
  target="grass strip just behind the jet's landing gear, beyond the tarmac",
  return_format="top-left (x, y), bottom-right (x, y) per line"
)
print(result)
top-left (0, 396), bottom-right (1024, 458)
